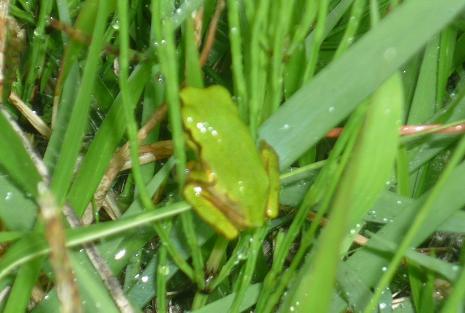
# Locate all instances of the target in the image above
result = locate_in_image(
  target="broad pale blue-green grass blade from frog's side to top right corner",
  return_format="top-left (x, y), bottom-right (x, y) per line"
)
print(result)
top-left (259, 0), bottom-right (465, 168)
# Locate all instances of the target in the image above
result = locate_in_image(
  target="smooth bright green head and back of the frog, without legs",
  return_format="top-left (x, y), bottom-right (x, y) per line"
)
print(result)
top-left (181, 86), bottom-right (268, 226)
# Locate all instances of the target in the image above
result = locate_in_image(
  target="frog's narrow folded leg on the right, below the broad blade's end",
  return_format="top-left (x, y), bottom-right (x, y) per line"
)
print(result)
top-left (260, 141), bottom-right (280, 218)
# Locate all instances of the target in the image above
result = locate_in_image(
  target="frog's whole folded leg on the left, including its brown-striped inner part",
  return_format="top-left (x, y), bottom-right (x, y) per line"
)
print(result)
top-left (183, 170), bottom-right (239, 240)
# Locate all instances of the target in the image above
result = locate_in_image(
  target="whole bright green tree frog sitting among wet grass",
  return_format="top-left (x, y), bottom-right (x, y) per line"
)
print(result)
top-left (181, 86), bottom-right (279, 239)
